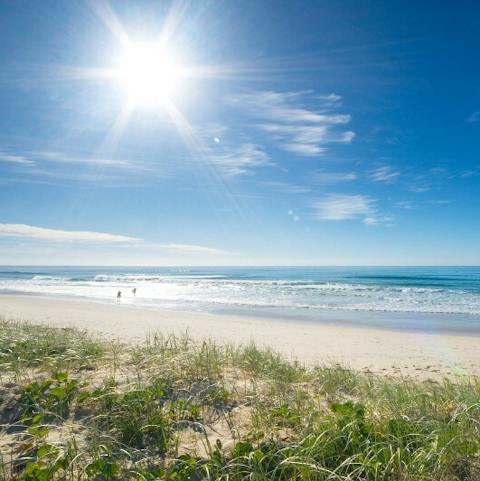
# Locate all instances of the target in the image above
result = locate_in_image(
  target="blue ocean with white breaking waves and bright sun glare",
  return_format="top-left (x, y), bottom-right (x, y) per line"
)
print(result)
top-left (0, 266), bottom-right (480, 332)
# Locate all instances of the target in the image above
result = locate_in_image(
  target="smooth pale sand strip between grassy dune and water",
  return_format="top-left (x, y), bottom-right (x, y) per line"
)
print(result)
top-left (0, 294), bottom-right (480, 379)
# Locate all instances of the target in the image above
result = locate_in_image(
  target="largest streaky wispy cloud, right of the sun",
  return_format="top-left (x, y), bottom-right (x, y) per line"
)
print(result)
top-left (229, 91), bottom-right (355, 156)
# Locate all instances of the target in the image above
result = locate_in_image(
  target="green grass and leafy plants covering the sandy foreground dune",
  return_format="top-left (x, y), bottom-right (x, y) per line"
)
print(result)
top-left (0, 321), bottom-right (480, 481)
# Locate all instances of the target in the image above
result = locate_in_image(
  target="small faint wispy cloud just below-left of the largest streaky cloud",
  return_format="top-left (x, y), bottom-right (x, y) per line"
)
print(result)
top-left (207, 143), bottom-right (273, 176)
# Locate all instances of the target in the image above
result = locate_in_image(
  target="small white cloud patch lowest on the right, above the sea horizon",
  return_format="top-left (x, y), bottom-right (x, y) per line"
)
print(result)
top-left (312, 194), bottom-right (377, 223)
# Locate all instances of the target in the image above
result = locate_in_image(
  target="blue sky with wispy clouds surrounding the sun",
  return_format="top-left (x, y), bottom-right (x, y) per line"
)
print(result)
top-left (0, 0), bottom-right (480, 265)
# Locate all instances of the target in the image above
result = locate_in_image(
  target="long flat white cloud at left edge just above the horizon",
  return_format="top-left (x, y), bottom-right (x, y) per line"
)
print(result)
top-left (0, 224), bottom-right (142, 242)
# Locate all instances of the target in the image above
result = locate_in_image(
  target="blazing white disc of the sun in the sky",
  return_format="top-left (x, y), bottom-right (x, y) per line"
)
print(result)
top-left (116, 43), bottom-right (181, 108)
